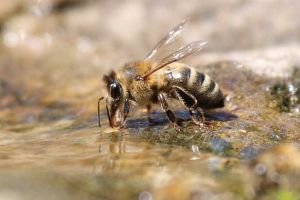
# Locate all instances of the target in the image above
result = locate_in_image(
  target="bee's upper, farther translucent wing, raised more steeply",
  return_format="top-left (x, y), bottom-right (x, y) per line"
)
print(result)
top-left (145, 20), bottom-right (188, 60)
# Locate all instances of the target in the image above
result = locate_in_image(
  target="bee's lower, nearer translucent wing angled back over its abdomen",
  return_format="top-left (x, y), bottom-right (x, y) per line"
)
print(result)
top-left (143, 41), bottom-right (207, 78)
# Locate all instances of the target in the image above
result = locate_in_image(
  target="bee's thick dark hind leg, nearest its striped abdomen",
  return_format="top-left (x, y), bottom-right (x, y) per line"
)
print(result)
top-left (172, 86), bottom-right (205, 126)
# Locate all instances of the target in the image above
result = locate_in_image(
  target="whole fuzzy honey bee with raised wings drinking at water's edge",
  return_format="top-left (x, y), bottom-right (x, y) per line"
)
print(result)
top-left (98, 21), bottom-right (224, 127)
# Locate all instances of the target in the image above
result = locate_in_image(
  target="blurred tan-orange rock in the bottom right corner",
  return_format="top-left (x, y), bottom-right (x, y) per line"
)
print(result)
top-left (251, 144), bottom-right (300, 195)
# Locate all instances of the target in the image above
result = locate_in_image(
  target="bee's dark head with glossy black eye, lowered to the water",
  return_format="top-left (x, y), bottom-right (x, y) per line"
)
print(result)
top-left (103, 71), bottom-right (124, 126)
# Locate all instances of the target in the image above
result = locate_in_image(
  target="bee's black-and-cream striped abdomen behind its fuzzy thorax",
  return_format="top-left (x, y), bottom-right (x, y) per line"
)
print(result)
top-left (164, 63), bottom-right (224, 108)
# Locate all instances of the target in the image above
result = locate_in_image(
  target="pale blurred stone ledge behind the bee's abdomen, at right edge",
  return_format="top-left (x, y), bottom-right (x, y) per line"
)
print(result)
top-left (202, 44), bottom-right (300, 78)
